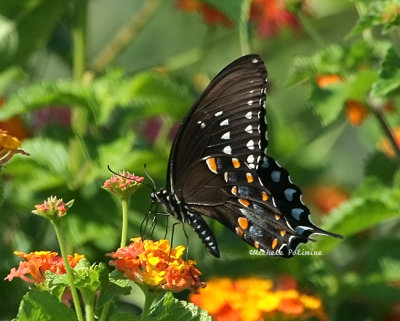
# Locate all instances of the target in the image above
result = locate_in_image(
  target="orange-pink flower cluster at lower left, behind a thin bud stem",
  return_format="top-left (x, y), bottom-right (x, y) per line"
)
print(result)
top-left (5, 251), bottom-right (84, 283)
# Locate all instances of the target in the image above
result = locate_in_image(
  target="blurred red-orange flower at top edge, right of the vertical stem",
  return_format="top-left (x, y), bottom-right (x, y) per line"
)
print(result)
top-left (250, 0), bottom-right (300, 38)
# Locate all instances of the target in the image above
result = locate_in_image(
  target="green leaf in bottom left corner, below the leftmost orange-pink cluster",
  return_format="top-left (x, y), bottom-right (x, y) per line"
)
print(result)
top-left (18, 291), bottom-right (77, 321)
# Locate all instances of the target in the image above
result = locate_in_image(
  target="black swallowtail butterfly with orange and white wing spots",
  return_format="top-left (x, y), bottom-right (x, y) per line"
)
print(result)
top-left (151, 55), bottom-right (341, 257)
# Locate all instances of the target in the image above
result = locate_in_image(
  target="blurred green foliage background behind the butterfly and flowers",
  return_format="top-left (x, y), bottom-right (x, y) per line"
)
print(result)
top-left (0, 0), bottom-right (400, 320)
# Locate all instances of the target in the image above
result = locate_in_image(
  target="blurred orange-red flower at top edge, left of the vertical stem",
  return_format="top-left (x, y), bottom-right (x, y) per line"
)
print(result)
top-left (176, 0), bottom-right (233, 27)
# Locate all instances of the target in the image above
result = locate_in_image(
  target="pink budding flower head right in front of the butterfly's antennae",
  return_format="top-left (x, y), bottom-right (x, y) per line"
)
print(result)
top-left (101, 171), bottom-right (144, 198)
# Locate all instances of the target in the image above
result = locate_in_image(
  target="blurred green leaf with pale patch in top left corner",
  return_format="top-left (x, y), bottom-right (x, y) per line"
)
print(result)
top-left (0, 0), bottom-right (70, 70)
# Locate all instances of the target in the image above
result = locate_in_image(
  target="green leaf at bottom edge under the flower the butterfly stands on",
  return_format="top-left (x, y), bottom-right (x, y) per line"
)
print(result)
top-left (146, 292), bottom-right (212, 321)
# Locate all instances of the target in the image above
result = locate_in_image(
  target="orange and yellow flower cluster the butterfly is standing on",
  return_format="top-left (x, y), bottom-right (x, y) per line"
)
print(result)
top-left (108, 237), bottom-right (205, 292)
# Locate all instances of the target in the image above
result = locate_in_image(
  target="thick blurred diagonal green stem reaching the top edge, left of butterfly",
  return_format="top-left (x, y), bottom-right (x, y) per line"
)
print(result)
top-left (92, 0), bottom-right (162, 73)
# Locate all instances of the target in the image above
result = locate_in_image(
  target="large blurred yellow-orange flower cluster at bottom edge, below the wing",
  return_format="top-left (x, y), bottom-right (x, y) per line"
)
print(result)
top-left (190, 277), bottom-right (326, 321)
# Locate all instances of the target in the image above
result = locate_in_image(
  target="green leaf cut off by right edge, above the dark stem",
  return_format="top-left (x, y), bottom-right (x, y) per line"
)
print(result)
top-left (371, 47), bottom-right (400, 97)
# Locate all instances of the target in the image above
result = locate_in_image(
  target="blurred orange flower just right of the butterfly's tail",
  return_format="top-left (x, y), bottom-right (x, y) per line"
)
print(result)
top-left (304, 185), bottom-right (349, 214)
